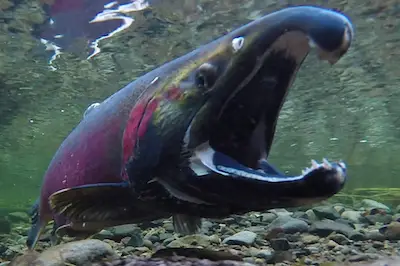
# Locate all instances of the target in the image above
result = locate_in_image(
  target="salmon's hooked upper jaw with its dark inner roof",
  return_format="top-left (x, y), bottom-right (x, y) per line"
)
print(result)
top-left (192, 7), bottom-right (354, 168)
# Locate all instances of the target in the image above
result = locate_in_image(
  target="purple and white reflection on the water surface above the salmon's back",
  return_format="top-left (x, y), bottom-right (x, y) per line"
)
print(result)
top-left (39, 0), bottom-right (149, 66)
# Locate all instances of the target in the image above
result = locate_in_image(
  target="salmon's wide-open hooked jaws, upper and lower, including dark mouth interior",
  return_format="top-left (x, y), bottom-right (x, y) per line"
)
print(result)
top-left (144, 7), bottom-right (353, 211)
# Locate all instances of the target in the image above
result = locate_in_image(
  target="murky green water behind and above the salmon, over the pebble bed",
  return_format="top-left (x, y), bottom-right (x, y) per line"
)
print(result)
top-left (0, 0), bottom-right (400, 210)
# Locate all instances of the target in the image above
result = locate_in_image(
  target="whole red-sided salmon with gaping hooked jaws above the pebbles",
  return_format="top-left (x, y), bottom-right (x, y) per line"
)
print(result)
top-left (27, 6), bottom-right (354, 248)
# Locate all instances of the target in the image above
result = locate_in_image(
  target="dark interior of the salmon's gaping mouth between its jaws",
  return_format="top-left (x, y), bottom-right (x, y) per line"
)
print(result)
top-left (192, 31), bottom-right (316, 179)
